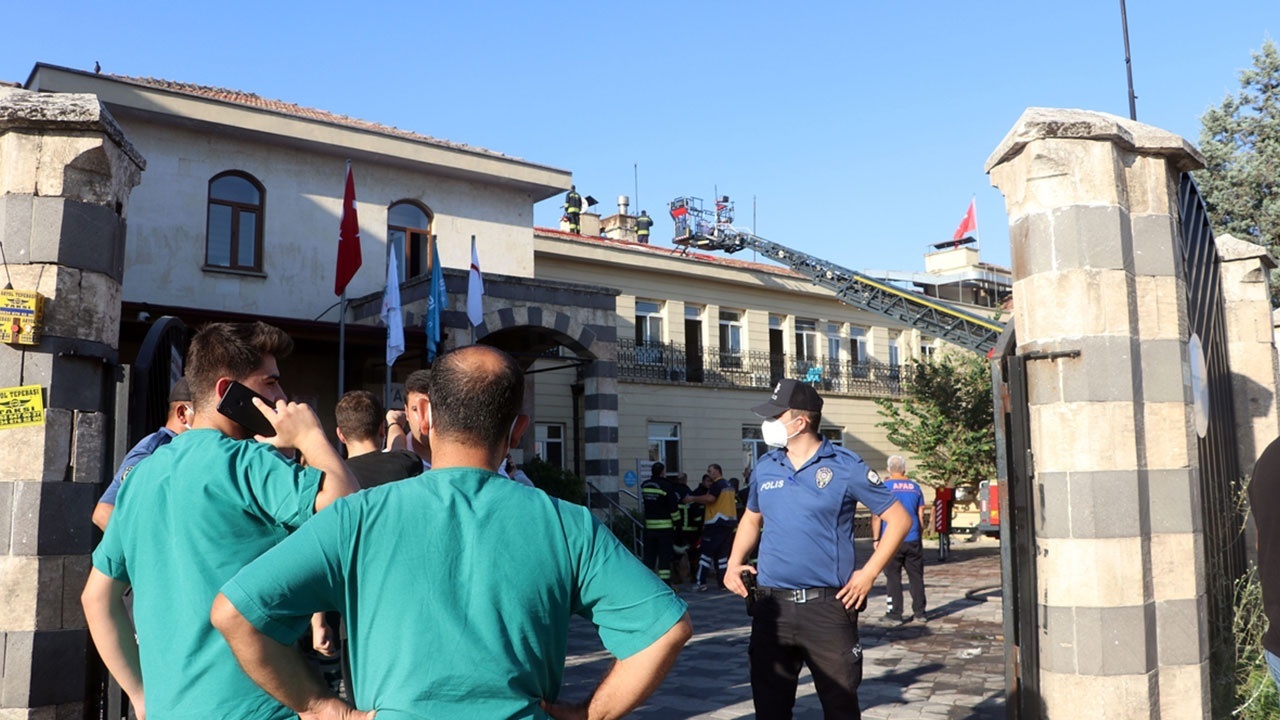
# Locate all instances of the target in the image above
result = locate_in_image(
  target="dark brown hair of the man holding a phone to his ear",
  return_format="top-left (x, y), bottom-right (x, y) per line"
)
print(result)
top-left (186, 322), bottom-right (293, 404)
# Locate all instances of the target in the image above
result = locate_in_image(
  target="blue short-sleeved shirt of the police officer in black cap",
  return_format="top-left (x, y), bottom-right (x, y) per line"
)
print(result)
top-left (746, 439), bottom-right (896, 589)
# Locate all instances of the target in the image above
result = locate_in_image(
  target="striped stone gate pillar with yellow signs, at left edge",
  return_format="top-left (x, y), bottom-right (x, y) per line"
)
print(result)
top-left (0, 88), bottom-right (145, 720)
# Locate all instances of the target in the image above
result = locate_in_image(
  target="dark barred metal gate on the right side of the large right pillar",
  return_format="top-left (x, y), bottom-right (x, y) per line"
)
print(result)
top-left (1178, 173), bottom-right (1245, 717)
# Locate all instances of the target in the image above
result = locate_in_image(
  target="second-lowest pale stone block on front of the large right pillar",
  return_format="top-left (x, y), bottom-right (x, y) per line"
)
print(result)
top-left (1037, 537), bottom-right (1143, 607)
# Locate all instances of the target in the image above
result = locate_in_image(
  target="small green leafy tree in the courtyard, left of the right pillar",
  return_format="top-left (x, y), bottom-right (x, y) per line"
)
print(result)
top-left (876, 352), bottom-right (996, 488)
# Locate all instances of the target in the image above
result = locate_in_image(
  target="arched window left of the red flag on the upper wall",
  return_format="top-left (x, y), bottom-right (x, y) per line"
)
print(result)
top-left (205, 170), bottom-right (266, 272)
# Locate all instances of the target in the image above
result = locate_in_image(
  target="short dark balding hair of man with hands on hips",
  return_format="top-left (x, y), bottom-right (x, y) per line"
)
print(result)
top-left (426, 345), bottom-right (525, 448)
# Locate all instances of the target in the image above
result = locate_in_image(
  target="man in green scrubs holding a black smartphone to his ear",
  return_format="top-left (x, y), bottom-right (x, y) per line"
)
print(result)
top-left (82, 323), bottom-right (358, 720)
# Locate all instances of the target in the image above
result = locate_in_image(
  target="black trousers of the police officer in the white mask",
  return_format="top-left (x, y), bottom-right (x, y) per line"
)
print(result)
top-left (748, 593), bottom-right (863, 720)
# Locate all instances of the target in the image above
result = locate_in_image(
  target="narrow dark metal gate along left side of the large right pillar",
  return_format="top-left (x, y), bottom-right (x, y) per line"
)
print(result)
top-left (992, 333), bottom-right (1043, 720)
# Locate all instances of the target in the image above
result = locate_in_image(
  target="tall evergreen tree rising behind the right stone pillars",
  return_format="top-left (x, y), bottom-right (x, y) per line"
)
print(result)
top-left (1196, 38), bottom-right (1280, 306)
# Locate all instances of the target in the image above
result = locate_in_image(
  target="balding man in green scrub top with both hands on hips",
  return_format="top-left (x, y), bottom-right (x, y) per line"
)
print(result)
top-left (212, 345), bottom-right (691, 720)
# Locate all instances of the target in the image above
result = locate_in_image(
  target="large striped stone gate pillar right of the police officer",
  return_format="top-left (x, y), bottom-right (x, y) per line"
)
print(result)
top-left (987, 108), bottom-right (1210, 720)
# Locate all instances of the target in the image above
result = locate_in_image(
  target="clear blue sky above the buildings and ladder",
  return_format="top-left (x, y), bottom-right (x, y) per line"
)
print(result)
top-left (0, 0), bottom-right (1280, 270)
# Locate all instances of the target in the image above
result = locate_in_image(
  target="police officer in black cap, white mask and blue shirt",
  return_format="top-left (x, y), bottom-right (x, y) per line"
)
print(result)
top-left (724, 378), bottom-right (911, 720)
